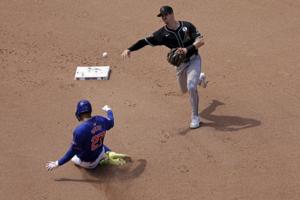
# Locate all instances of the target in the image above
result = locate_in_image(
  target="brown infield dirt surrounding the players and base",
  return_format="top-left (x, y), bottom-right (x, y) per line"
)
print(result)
top-left (0, 0), bottom-right (300, 200)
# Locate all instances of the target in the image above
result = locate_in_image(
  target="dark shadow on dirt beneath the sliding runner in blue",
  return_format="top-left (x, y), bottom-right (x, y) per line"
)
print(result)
top-left (55, 159), bottom-right (147, 184)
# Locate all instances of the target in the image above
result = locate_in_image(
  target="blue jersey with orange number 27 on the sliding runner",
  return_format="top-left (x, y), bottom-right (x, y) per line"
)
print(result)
top-left (58, 110), bottom-right (114, 165)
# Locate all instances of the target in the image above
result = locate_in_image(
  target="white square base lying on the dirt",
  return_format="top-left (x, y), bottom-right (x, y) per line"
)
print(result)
top-left (75, 66), bottom-right (110, 80)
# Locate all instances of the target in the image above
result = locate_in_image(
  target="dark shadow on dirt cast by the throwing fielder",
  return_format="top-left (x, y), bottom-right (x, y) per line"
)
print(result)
top-left (177, 100), bottom-right (261, 135)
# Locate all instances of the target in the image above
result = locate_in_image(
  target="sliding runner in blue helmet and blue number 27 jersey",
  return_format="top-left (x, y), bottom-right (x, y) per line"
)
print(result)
top-left (46, 100), bottom-right (127, 171)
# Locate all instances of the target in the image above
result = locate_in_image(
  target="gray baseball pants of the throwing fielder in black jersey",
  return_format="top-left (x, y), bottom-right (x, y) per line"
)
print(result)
top-left (176, 55), bottom-right (201, 116)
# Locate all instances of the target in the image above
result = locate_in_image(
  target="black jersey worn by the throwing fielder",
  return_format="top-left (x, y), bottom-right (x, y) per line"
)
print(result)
top-left (128, 21), bottom-right (202, 57)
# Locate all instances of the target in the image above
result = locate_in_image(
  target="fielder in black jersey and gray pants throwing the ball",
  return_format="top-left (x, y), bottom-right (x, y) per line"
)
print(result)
top-left (122, 6), bottom-right (207, 128)
